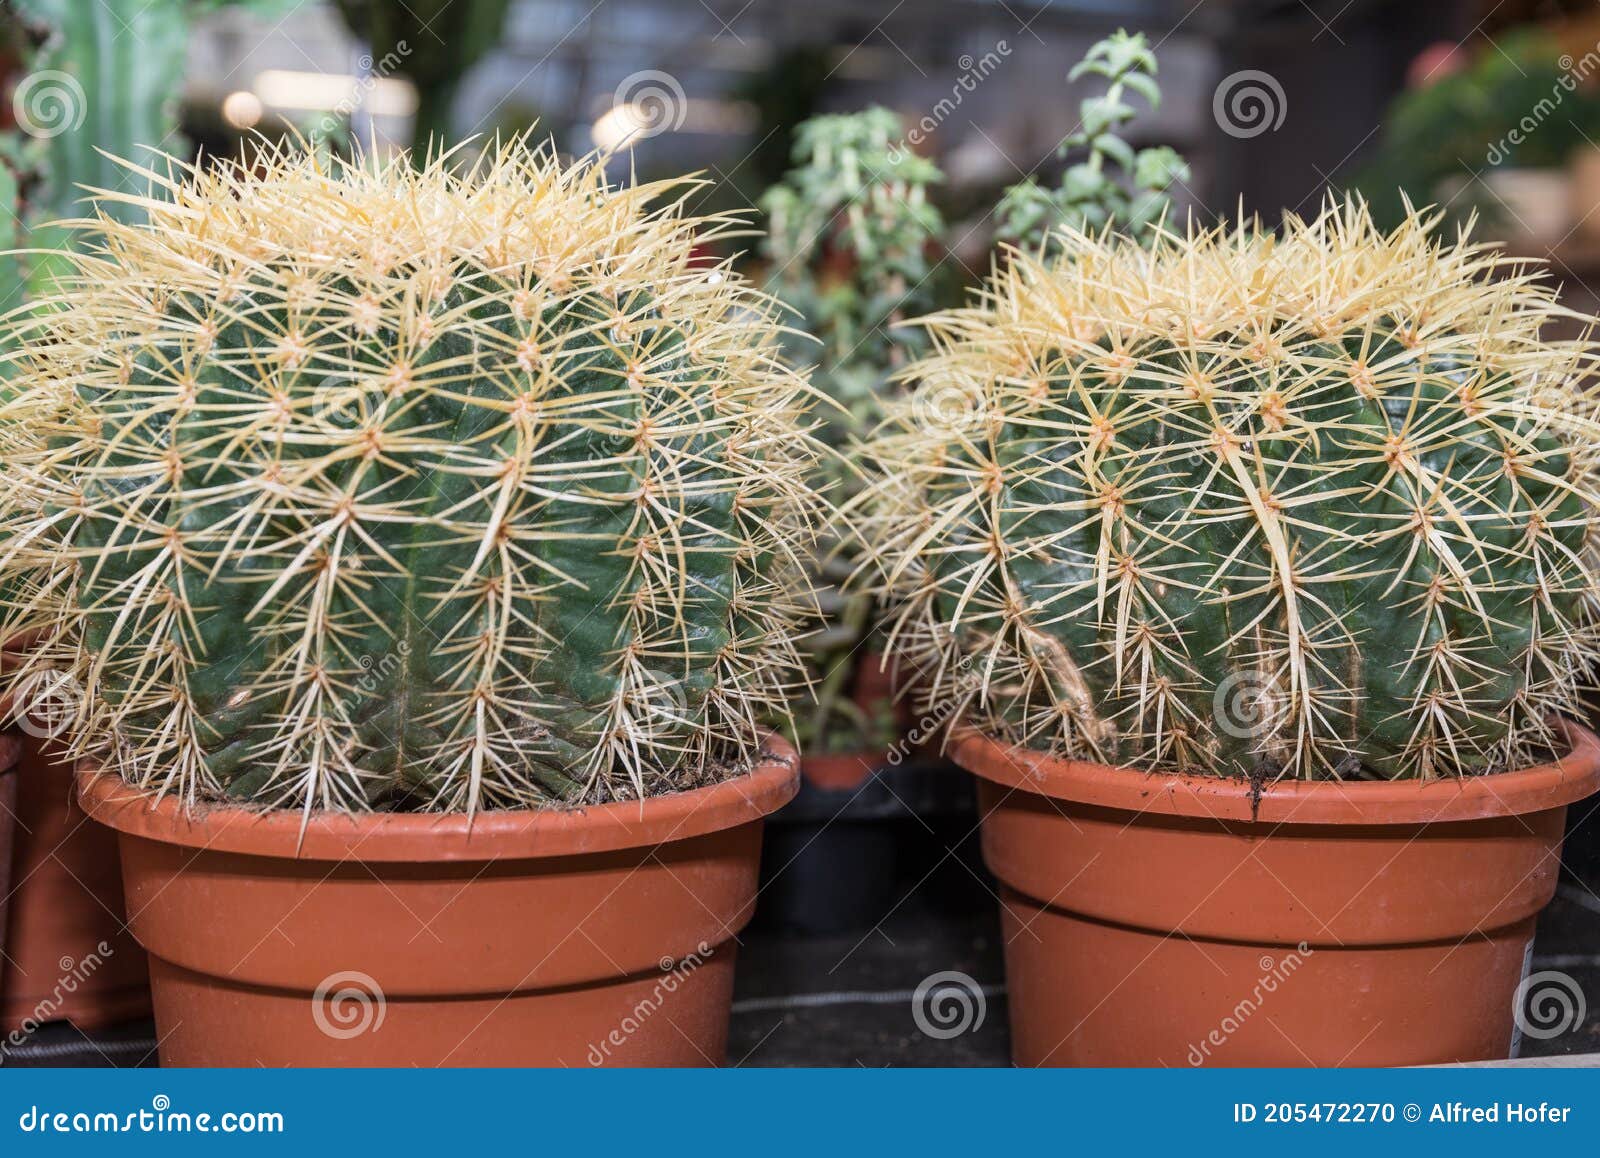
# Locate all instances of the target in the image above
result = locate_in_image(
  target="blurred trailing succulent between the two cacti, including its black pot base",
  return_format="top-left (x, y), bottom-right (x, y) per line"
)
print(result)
top-left (748, 109), bottom-right (970, 934)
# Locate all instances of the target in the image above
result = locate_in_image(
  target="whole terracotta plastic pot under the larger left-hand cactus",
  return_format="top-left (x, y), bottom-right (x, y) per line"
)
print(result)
top-left (78, 737), bottom-right (798, 1067)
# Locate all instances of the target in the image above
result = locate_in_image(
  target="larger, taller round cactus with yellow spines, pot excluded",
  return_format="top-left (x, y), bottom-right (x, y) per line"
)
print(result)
top-left (6, 142), bottom-right (816, 811)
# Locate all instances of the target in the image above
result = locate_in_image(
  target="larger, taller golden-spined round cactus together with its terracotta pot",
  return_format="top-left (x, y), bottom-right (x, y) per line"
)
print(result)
top-left (13, 141), bottom-right (821, 1065)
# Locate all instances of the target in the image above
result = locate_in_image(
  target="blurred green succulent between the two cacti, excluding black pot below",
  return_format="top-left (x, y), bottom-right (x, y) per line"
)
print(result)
top-left (762, 109), bottom-right (944, 789)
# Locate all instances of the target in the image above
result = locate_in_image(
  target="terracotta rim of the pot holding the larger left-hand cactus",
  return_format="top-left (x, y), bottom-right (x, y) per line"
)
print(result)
top-left (77, 734), bottom-right (800, 864)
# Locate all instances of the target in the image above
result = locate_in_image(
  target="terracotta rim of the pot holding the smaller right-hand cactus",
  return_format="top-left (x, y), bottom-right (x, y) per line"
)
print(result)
top-left (949, 718), bottom-right (1600, 825)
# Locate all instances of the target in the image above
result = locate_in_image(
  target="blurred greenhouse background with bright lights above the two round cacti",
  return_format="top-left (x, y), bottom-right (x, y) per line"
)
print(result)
top-left (15, 0), bottom-right (1600, 262)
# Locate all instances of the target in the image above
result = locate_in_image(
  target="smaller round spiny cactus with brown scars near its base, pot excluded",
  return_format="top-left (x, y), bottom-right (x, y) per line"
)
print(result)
top-left (874, 205), bottom-right (1595, 781)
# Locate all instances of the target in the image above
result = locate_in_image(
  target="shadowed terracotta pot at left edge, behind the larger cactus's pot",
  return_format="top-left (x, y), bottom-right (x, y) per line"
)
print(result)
top-left (0, 638), bottom-right (150, 1036)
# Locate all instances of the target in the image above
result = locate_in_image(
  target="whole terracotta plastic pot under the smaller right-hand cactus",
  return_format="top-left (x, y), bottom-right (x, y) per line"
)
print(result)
top-left (952, 723), bottom-right (1600, 1067)
